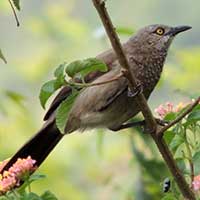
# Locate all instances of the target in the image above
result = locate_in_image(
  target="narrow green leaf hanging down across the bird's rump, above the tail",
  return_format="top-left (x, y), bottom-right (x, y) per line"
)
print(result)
top-left (56, 91), bottom-right (79, 133)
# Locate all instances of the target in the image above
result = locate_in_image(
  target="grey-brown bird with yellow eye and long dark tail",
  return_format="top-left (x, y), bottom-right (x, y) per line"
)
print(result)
top-left (1, 24), bottom-right (191, 172)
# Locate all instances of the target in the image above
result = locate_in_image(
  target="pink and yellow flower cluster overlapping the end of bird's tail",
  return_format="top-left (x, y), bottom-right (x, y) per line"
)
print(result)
top-left (0, 156), bottom-right (36, 195)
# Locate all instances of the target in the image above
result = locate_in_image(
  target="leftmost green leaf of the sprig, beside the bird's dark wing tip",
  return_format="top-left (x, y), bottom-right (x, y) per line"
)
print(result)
top-left (39, 80), bottom-right (63, 108)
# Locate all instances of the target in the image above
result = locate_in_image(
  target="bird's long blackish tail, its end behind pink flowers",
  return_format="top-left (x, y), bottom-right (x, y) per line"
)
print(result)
top-left (2, 122), bottom-right (63, 171)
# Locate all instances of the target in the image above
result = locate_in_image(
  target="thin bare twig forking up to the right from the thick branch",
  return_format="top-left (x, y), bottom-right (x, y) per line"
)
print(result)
top-left (157, 97), bottom-right (200, 137)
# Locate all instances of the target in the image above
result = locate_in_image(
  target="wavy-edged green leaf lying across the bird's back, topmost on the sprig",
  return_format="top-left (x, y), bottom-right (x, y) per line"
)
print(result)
top-left (65, 58), bottom-right (108, 78)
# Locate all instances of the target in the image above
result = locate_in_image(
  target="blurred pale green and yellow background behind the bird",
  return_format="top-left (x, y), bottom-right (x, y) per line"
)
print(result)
top-left (0, 0), bottom-right (200, 200)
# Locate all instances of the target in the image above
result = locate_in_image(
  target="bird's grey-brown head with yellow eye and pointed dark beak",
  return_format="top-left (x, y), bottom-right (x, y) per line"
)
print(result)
top-left (134, 24), bottom-right (191, 51)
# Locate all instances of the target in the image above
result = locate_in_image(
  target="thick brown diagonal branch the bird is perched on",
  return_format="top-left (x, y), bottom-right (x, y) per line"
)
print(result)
top-left (92, 0), bottom-right (195, 200)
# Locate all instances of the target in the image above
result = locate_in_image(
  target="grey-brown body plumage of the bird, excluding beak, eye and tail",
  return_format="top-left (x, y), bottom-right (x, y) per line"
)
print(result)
top-left (65, 25), bottom-right (184, 133)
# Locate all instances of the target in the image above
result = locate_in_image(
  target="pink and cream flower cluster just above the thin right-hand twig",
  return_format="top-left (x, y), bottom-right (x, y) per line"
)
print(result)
top-left (155, 102), bottom-right (188, 119)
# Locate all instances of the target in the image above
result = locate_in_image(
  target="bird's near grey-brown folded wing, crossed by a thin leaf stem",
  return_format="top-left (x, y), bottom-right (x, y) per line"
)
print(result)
top-left (69, 67), bottom-right (128, 115)
